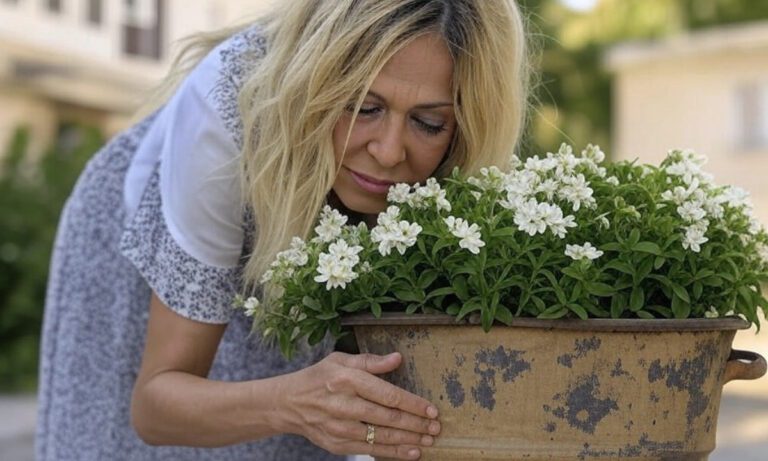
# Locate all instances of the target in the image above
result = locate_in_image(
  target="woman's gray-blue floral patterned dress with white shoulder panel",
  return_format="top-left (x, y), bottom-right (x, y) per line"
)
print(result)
top-left (36, 27), bottom-right (342, 461)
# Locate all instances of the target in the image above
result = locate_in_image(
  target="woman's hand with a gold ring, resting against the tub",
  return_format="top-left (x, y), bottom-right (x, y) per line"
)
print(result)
top-left (281, 352), bottom-right (440, 459)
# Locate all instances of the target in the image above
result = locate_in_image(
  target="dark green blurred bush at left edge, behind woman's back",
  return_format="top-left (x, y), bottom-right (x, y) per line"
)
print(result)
top-left (0, 127), bottom-right (104, 391)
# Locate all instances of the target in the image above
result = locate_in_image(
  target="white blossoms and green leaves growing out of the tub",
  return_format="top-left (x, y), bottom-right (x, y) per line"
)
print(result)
top-left (239, 145), bottom-right (768, 355)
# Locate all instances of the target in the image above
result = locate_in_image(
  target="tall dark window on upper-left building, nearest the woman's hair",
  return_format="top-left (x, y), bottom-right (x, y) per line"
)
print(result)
top-left (123, 0), bottom-right (165, 60)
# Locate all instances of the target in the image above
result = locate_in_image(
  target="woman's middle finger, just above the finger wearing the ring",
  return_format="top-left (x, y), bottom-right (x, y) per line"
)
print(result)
top-left (343, 399), bottom-right (440, 434)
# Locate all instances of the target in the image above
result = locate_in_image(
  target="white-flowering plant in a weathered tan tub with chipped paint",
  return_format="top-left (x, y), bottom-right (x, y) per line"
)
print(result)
top-left (240, 145), bottom-right (768, 460)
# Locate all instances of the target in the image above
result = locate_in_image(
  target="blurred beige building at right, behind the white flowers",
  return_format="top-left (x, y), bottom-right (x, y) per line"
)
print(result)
top-left (607, 22), bottom-right (768, 224)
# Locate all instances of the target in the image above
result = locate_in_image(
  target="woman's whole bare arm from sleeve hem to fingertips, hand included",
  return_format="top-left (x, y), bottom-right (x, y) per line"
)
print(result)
top-left (131, 294), bottom-right (440, 459)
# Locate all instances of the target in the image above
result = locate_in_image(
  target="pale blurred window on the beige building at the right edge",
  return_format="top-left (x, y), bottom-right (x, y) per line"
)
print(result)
top-left (736, 82), bottom-right (768, 150)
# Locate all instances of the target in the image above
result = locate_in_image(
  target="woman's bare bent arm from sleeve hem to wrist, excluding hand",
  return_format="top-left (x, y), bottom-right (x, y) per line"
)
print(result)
top-left (131, 293), bottom-right (280, 447)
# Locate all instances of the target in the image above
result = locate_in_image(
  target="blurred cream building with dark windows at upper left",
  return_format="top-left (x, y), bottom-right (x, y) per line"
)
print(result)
top-left (0, 0), bottom-right (273, 155)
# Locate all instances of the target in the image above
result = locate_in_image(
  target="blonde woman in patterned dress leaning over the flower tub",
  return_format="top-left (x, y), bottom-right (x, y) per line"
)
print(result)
top-left (36, 0), bottom-right (527, 460)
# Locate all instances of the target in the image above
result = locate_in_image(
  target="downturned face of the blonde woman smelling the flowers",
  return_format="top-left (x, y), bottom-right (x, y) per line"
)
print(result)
top-left (333, 33), bottom-right (456, 214)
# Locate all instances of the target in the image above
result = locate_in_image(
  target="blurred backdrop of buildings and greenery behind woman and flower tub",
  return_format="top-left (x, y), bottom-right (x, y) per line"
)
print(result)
top-left (0, 0), bottom-right (768, 461)
